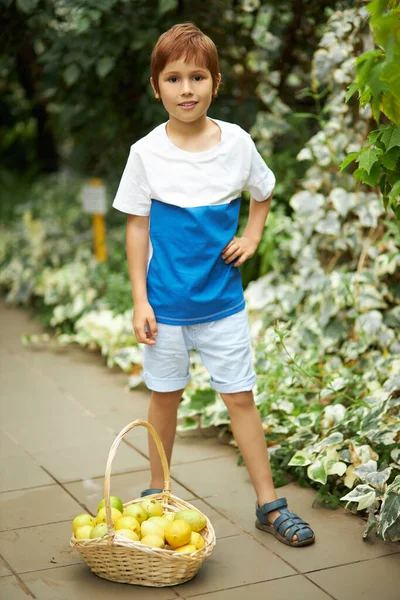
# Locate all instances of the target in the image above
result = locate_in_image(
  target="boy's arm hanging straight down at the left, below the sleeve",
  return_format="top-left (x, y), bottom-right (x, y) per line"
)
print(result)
top-left (126, 215), bottom-right (157, 345)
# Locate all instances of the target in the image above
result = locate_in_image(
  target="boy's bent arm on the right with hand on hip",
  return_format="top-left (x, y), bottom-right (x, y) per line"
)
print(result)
top-left (222, 194), bottom-right (272, 267)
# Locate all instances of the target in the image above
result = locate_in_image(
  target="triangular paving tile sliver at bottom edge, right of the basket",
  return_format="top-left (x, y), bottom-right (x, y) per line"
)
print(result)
top-left (184, 575), bottom-right (332, 600)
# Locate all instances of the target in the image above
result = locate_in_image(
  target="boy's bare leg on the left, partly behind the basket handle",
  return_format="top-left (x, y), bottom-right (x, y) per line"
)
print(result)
top-left (148, 389), bottom-right (183, 489)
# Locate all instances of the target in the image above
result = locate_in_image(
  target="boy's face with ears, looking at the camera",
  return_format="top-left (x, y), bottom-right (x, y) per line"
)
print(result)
top-left (150, 58), bottom-right (221, 123)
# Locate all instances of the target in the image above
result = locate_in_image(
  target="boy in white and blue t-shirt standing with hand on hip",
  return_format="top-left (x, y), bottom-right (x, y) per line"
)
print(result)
top-left (113, 23), bottom-right (314, 546)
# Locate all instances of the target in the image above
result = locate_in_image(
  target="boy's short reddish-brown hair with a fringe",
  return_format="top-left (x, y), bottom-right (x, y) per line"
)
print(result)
top-left (150, 23), bottom-right (219, 97)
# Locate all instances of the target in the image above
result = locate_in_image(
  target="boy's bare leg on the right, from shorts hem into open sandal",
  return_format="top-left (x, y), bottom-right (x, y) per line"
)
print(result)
top-left (220, 392), bottom-right (297, 541)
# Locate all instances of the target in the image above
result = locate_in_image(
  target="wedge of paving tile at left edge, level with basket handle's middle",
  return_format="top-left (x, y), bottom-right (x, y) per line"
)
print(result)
top-left (0, 454), bottom-right (54, 492)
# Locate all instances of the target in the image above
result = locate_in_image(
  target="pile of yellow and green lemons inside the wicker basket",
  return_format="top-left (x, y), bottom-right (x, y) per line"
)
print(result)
top-left (72, 496), bottom-right (206, 554)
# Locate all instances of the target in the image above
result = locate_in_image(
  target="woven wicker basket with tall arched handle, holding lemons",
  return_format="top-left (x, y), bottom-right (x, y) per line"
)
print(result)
top-left (70, 419), bottom-right (215, 587)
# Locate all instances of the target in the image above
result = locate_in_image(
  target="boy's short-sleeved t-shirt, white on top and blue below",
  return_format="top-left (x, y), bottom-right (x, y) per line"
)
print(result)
top-left (113, 119), bottom-right (275, 325)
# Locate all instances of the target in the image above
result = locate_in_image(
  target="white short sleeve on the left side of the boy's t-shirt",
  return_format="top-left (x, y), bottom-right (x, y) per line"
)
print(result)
top-left (113, 145), bottom-right (151, 217)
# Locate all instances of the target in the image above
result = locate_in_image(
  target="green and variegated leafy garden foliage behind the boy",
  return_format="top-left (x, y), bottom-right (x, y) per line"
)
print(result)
top-left (0, 0), bottom-right (400, 540)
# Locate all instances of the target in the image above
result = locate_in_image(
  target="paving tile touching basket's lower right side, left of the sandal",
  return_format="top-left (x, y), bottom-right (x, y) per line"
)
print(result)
top-left (177, 535), bottom-right (295, 598)
